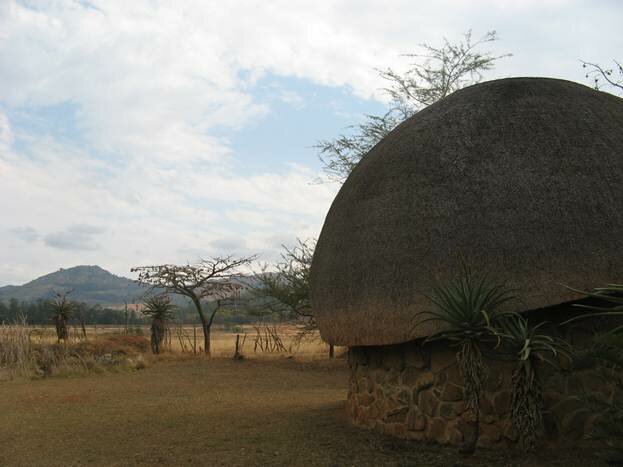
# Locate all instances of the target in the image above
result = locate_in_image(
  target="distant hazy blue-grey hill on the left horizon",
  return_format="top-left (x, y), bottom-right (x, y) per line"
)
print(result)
top-left (0, 266), bottom-right (147, 305)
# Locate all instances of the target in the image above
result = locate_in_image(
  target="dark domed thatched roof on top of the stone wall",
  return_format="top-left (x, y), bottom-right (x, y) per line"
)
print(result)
top-left (311, 78), bottom-right (623, 346)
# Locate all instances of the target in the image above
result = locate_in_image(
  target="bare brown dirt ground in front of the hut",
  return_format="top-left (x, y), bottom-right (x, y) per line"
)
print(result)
top-left (0, 357), bottom-right (600, 466)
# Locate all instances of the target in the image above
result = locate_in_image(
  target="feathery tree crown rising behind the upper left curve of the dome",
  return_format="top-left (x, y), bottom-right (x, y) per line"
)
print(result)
top-left (316, 31), bottom-right (511, 182)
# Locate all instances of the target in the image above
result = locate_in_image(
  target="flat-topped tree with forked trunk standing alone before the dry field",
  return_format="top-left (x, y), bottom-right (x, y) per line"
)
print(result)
top-left (131, 255), bottom-right (255, 356)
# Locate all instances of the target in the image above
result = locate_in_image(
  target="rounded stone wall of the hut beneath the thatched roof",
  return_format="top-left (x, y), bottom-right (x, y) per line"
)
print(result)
top-left (347, 341), bottom-right (621, 447)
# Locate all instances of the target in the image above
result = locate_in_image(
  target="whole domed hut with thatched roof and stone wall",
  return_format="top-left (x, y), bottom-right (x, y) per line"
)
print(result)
top-left (311, 78), bottom-right (623, 445)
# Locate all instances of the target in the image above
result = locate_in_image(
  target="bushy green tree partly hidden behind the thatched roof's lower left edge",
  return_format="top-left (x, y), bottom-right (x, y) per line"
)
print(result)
top-left (255, 238), bottom-right (334, 358)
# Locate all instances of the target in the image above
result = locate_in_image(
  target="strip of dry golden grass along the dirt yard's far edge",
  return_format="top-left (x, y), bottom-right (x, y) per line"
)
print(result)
top-left (0, 323), bottom-right (345, 381)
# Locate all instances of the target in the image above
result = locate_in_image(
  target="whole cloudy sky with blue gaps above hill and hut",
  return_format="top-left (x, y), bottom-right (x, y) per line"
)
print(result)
top-left (0, 0), bottom-right (623, 285)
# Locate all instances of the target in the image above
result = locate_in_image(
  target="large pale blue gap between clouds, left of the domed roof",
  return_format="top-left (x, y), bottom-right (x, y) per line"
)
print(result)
top-left (215, 74), bottom-right (385, 171)
